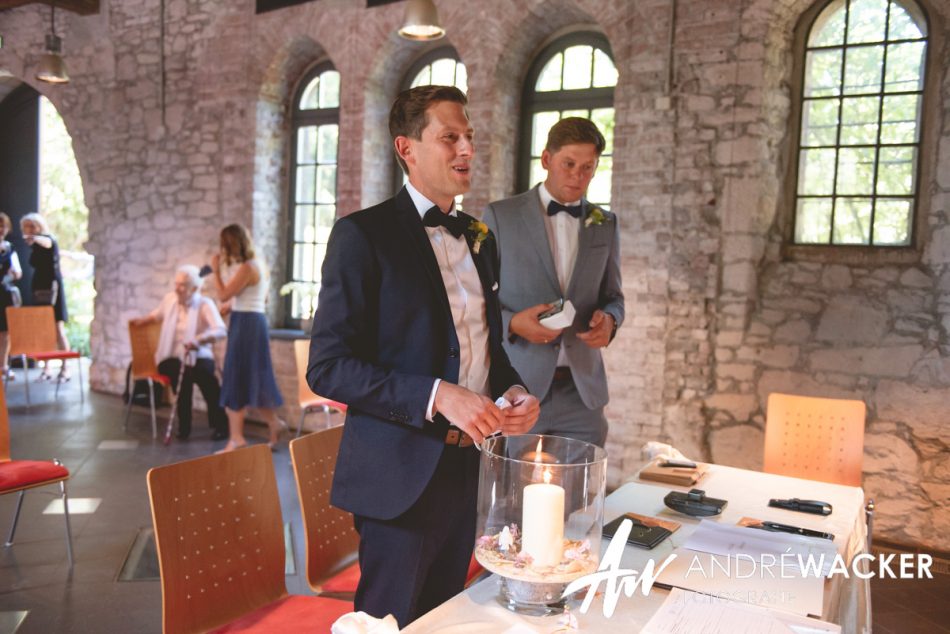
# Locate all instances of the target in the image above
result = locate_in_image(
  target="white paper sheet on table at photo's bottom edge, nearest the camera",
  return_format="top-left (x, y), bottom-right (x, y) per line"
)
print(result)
top-left (642, 588), bottom-right (841, 634)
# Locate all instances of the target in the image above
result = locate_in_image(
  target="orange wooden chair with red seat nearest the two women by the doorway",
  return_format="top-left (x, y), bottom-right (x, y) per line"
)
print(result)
top-left (7, 306), bottom-right (85, 407)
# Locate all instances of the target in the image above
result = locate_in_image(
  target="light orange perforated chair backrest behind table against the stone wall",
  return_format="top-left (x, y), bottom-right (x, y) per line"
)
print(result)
top-left (763, 393), bottom-right (867, 486)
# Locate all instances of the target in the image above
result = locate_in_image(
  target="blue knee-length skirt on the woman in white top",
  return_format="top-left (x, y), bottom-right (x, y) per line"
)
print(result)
top-left (221, 311), bottom-right (284, 410)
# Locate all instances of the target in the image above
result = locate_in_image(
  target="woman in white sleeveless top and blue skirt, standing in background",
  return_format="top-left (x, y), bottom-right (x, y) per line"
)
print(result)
top-left (211, 224), bottom-right (284, 453)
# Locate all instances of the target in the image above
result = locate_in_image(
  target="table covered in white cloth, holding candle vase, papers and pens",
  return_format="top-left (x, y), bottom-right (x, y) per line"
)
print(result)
top-left (403, 465), bottom-right (871, 634)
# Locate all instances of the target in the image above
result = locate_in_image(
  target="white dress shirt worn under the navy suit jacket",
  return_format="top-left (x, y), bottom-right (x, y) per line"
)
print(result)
top-left (406, 183), bottom-right (490, 420)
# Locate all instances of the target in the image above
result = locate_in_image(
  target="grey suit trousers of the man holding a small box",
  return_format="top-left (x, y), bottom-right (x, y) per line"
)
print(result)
top-left (531, 377), bottom-right (607, 447)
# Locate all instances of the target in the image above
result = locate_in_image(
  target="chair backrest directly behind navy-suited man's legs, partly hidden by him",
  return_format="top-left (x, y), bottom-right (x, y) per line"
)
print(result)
top-left (290, 425), bottom-right (360, 590)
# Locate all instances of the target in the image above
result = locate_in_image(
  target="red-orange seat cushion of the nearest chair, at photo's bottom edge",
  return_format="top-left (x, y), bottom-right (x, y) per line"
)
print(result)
top-left (212, 594), bottom-right (353, 634)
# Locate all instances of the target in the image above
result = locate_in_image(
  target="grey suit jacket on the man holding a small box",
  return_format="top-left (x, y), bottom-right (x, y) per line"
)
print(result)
top-left (484, 187), bottom-right (624, 409)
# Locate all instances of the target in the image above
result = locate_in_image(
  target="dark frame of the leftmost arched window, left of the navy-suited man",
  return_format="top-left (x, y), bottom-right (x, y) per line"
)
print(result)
top-left (283, 60), bottom-right (343, 330)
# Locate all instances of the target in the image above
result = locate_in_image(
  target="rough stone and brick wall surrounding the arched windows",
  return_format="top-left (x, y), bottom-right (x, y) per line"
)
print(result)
top-left (0, 0), bottom-right (950, 546)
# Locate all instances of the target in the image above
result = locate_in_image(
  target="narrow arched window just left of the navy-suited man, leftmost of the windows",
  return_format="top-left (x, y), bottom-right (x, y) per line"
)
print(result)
top-left (287, 62), bottom-right (340, 320)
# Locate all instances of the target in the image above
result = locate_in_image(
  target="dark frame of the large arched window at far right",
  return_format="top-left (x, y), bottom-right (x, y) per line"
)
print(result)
top-left (781, 0), bottom-right (943, 265)
